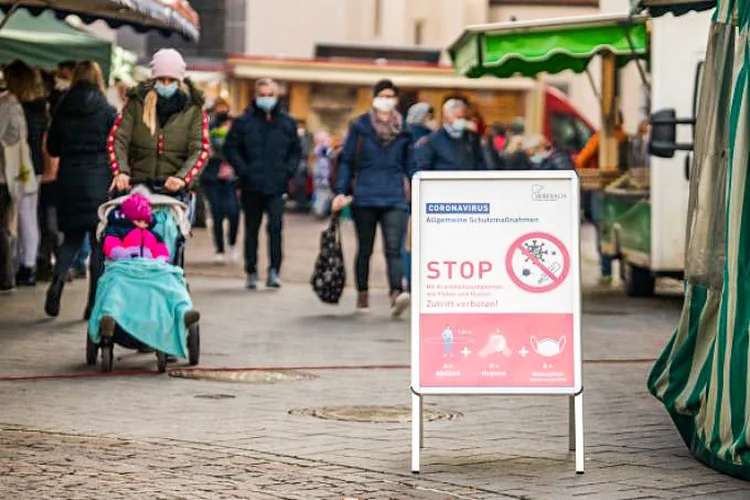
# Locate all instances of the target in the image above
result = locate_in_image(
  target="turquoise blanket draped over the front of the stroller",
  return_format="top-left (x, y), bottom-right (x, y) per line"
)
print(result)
top-left (89, 259), bottom-right (193, 358)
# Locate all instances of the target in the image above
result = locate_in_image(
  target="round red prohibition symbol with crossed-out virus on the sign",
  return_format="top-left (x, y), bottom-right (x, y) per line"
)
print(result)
top-left (505, 232), bottom-right (570, 293)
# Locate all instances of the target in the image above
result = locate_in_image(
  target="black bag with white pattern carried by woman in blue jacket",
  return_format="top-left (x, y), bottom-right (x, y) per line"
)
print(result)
top-left (310, 215), bottom-right (346, 304)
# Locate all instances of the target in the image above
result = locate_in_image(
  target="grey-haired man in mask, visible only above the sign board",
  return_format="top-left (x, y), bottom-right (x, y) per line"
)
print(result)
top-left (415, 99), bottom-right (487, 170)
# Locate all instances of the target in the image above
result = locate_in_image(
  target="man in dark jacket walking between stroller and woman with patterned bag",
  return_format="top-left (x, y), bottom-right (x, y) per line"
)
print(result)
top-left (224, 78), bottom-right (301, 290)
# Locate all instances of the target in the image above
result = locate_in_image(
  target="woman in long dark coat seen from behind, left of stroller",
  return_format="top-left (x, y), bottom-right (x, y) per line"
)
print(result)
top-left (44, 61), bottom-right (117, 318)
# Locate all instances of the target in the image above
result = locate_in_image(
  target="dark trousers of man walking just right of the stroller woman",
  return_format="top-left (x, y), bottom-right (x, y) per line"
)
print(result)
top-left (242, 191), bottom-right (284, 274)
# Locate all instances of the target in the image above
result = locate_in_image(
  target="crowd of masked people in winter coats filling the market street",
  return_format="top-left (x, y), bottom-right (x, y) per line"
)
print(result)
top-left (0, 49), bottom-right (648, 316)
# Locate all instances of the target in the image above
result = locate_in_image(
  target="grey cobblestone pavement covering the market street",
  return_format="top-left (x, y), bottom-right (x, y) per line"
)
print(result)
top-left (0, 217), bottom-right (750, 500)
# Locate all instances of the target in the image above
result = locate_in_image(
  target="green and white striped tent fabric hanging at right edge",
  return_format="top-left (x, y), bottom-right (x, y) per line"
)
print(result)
top-left (643, 0), bottom-right (750, 480)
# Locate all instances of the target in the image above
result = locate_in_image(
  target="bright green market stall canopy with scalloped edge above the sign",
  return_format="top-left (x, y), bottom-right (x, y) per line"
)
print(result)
top-left (448, 15), bottom-right (648, 78)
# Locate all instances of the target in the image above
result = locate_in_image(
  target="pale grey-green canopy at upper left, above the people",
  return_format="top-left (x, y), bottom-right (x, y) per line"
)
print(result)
top-left (0, 10), bottom-right (112, 81)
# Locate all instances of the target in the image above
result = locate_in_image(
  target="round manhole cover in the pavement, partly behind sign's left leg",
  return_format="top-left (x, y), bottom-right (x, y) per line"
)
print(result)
top-left (289, 406), bottom-right (462, 423)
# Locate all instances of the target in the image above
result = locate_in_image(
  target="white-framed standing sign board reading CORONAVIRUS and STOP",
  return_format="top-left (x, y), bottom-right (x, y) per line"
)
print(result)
top-left (411, 171), bottom-right (583, 472)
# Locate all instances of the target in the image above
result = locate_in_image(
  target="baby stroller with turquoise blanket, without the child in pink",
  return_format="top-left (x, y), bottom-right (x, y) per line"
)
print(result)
top-left (86, 181), bottom-right (200, 373)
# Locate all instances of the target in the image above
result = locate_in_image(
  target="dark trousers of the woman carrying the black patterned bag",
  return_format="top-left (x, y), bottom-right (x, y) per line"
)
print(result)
top-left (352, 207), bottom-right (408, 293)
